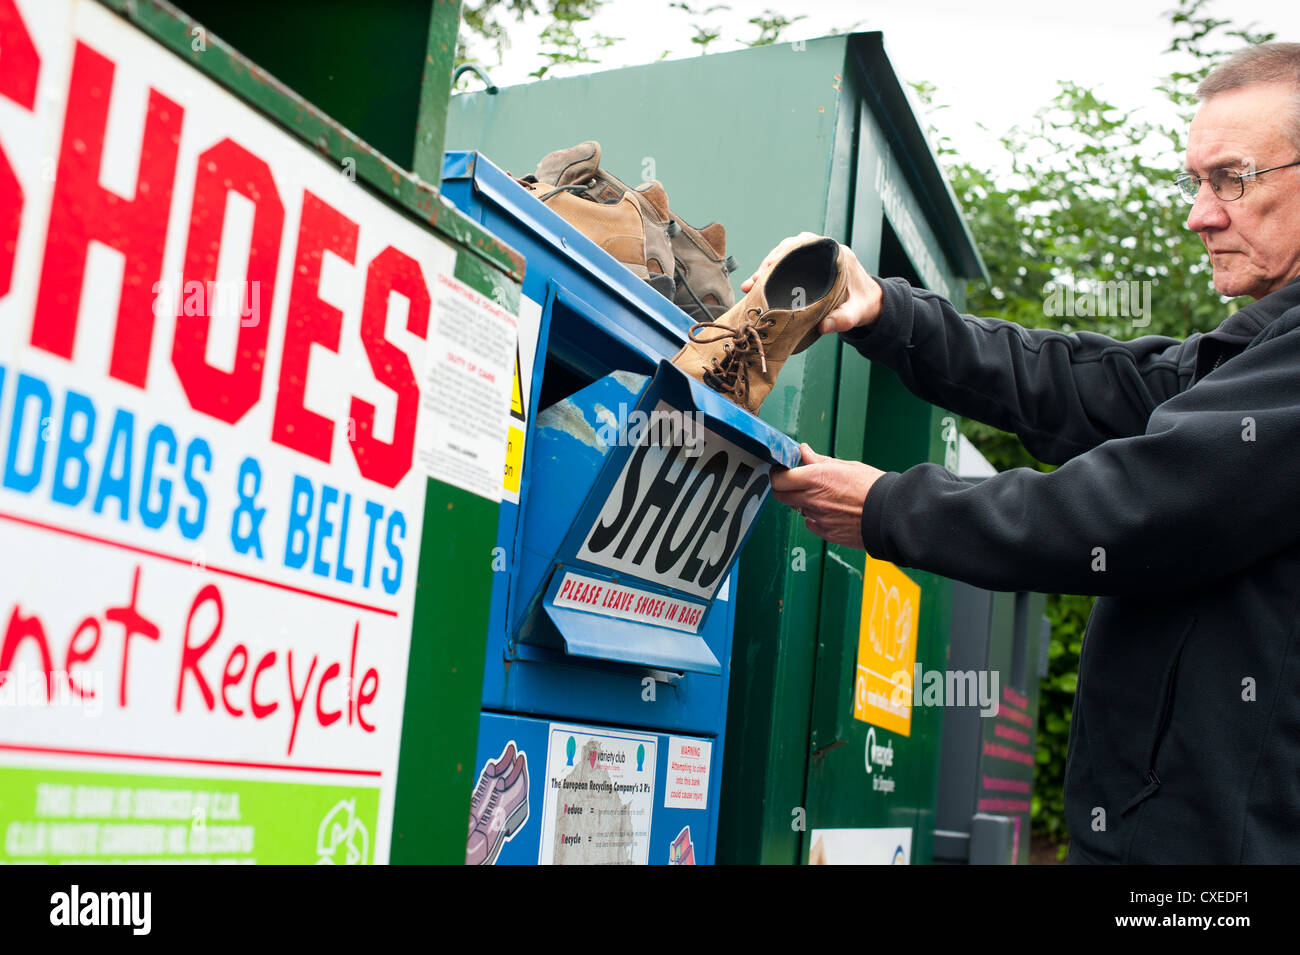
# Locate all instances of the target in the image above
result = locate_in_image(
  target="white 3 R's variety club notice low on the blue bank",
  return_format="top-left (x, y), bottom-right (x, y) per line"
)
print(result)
top-left (538, 722), bottom-right (657, 865)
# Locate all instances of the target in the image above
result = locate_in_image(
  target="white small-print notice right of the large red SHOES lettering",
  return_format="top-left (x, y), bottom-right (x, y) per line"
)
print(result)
top-left (416, 274), bottom-right (519, 500)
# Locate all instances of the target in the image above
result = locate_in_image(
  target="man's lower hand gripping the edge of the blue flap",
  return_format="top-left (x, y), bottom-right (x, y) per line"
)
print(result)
top-left (772, 444), bottom-right (884, 551)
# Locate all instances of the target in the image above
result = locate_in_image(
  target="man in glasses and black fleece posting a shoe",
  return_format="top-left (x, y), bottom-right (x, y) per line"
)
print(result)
top-left (764, 43), bottom-right (1300, 863)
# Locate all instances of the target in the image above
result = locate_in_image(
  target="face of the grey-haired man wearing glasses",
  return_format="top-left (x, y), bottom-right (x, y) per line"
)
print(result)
top-left (1187, 83), bottom-right (1300, 299)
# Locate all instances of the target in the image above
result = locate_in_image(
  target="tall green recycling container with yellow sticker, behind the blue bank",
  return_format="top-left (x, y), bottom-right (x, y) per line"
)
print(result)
top-left (446, 32), bottom-right (984, 863)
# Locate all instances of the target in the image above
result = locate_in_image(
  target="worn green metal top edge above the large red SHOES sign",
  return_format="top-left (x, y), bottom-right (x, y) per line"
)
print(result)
top-left (95, 0), bottom-right (524, 282)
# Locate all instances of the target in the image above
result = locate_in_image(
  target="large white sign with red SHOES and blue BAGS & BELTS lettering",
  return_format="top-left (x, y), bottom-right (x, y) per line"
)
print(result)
top-left (0, 0), bottom-right (488, 863)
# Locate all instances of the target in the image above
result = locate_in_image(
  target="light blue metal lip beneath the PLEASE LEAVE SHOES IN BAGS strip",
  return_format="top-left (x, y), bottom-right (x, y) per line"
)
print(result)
top-left (545, 604), bottom-right (723, 676)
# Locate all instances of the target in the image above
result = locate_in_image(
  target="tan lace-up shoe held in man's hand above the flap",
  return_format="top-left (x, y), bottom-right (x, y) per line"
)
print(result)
top-left (672, 236), bottom-right (848, 414)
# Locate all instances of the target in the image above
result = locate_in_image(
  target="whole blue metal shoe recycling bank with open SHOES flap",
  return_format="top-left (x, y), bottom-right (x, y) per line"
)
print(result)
top-left (442, 152), bottom-right (800, 864)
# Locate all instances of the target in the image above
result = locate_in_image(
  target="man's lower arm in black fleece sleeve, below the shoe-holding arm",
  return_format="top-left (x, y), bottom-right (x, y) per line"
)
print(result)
top-left (863, 329), bottom-right (1300, 594)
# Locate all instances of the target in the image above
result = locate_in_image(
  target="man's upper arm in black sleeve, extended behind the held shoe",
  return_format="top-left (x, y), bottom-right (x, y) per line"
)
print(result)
top-left (842, 278), bottom-right (1200, 464)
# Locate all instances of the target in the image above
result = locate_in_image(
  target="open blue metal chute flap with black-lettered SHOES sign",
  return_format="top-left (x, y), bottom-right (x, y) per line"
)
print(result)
top-left (516, 361), bottom-right (800, 673)
